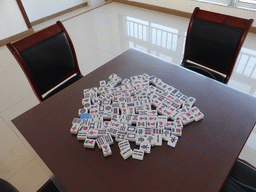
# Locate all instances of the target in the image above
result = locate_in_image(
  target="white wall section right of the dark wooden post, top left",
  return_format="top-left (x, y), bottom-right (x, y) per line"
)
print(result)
top-left (22, 0), bottom-right (87, 22)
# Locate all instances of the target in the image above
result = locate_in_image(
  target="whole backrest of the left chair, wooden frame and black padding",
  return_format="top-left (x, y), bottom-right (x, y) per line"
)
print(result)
top-left (7, 21), bottom-right (81, 101)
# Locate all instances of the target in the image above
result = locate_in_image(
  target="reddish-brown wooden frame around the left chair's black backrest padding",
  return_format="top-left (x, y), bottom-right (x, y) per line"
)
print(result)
top-left (6, 21), bottom-right (81, 102)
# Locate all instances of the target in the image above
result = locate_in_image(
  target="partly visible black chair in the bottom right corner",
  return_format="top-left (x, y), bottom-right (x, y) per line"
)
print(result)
top-left (221, 159), bottom-right (256, 192)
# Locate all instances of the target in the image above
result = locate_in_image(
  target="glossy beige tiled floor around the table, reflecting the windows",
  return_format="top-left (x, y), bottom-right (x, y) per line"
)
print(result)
top-left (0, 0), bottom-right (256, 192)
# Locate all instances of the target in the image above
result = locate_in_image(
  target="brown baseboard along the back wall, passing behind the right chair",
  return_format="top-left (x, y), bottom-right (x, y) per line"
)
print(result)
top-left (112, 0), bottom-right (256, 34)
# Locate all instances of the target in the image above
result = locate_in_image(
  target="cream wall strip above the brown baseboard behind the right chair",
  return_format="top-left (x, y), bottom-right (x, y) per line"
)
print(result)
top-left (129, 0), bottom-right (256, 27)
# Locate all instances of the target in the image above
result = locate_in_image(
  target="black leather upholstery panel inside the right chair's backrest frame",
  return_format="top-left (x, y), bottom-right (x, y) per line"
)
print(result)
top-left (187, 18), bottom-right (244, 71)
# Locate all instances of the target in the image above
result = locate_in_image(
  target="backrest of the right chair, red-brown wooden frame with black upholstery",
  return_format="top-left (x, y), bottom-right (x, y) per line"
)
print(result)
top-left (183, 7), bottom-right (253, 83)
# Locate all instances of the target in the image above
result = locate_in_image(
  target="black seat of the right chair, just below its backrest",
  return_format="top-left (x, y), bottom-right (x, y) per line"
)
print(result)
top-left (181, 62), bottom-right (225, 83)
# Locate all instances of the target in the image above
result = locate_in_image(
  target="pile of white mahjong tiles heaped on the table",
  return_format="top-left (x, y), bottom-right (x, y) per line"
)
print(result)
top-left (70, 73), bottom-right (204, 160)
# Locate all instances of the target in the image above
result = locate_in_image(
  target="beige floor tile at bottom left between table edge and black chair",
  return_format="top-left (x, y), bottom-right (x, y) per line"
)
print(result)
top-left (8, 160), bottom-right (50, 192)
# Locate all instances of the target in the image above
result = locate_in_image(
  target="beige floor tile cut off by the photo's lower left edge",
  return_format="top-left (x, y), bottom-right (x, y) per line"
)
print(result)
top-left (0, 117), bottom-right (33, 180)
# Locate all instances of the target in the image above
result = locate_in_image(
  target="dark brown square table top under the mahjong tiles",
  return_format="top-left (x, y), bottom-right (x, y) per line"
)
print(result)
top-left (13, 49), bottom-right (256, 192)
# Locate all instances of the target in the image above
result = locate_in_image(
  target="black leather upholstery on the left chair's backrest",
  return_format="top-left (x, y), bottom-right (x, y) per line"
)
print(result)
top-left (20, 32), bottom-right (75, 94)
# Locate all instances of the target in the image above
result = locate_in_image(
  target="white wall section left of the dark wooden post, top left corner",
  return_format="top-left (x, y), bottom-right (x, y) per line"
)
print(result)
top-left (0, 0), bottom-right (28, 40)
